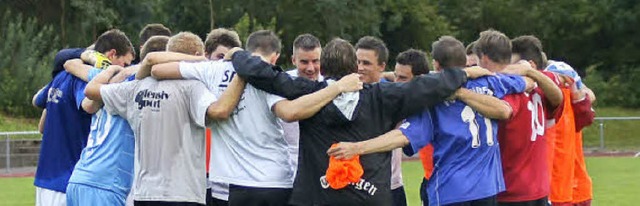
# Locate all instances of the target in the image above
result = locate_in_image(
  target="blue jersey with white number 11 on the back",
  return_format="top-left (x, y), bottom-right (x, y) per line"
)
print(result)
top-left (400, 75), bottom-right (525, 205)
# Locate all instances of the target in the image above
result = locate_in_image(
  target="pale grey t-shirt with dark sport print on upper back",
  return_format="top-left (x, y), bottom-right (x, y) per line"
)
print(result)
top-left (100, 77), bottom-right (216, 204)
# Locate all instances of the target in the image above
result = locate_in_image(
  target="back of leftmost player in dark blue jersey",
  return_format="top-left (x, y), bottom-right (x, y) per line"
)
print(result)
top-left (34, 71), bottom-right (91, 193)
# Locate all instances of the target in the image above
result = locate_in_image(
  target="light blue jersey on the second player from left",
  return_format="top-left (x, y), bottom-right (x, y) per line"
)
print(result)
top-left (67, 69), bottom-right (135, 199)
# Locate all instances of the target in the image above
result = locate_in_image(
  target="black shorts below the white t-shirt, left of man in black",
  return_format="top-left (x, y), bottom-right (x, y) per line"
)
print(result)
top-left (229, 185), bottom-right (292, 206)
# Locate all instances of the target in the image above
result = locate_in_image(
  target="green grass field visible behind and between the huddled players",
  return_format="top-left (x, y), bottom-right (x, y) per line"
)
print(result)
top-left (0, 157), bottom-right (640, 206)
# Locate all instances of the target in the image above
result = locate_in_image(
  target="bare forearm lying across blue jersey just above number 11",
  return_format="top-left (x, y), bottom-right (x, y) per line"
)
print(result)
top-left (454, 88), bottom-right (513, 120)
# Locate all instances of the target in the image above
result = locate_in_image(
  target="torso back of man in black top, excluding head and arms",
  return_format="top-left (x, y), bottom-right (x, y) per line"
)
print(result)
top-left (292, 83), bottom-right (400, 205)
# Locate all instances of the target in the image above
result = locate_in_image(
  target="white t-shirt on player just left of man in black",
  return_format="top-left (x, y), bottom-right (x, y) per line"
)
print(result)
top-left (180, 61), bottom-right (294, 188)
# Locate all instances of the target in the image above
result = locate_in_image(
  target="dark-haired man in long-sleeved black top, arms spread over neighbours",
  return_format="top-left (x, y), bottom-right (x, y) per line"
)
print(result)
top-left (233, 39), bottom-right (488, 205)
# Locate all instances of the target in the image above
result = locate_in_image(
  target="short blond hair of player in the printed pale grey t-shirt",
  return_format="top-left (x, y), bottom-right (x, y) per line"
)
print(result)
top-left (167, 32), bottom-right (204, 55)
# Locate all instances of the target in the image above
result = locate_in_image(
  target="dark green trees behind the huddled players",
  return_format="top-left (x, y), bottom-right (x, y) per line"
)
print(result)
top-left (0, 0), bottom-right (640, 116)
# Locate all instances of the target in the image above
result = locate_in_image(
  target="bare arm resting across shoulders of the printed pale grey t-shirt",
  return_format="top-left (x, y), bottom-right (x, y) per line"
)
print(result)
top-left (136, 52), bottom-right (207, 79)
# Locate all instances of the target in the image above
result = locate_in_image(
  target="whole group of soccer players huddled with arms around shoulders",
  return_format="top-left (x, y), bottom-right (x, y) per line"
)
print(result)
top-left (33, 21), bottom-right (595, 206)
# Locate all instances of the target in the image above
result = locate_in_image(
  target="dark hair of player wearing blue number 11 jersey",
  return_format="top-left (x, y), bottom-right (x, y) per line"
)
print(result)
top-left (431, 36), bottom-right (467, 69)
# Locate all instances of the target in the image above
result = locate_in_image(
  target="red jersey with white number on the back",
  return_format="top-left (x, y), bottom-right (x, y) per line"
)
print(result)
top-left (498, 72), bottom-right (561, 202)
